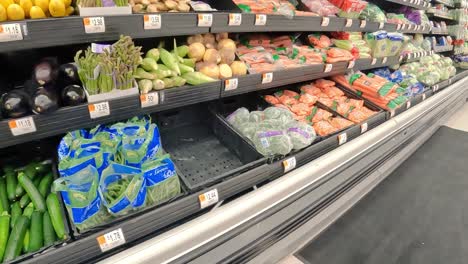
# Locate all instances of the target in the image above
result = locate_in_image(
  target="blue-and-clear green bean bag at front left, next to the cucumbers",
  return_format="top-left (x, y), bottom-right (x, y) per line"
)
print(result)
top-left (53, 165), bottom-right (111, 231)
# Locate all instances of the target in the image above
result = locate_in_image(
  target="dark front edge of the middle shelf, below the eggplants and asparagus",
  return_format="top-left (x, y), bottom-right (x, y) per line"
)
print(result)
top-left (0, 56), bottom-right (399, 148)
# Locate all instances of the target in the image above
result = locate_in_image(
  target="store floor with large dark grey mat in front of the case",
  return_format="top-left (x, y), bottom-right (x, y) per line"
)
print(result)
top-left (282, 105), bottom-right (468, 264)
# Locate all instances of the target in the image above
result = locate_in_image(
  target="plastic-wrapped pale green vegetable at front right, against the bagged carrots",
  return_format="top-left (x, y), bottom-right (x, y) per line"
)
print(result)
top-left (286, 121), bottom-right (317, 150)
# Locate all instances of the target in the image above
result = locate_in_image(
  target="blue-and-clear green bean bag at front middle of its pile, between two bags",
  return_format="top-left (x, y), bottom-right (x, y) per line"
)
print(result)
top-left (99, 163), bottom-right (146, 216)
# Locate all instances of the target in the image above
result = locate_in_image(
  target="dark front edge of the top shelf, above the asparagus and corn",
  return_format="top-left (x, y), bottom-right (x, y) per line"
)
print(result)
top-left (0, 12), bottom-right (430, 52)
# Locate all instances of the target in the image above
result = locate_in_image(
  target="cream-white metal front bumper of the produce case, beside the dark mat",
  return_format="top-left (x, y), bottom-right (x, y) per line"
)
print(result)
top-left (96, 74), bottom-right (466, 264)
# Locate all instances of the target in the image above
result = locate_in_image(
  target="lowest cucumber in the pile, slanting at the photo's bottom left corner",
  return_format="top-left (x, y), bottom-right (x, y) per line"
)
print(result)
top-left (3, 215), bottom-right (29, 262)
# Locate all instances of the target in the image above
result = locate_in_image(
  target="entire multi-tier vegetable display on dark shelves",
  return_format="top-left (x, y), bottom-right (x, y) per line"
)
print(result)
top-left (0, 0), bottom-right (468, 263)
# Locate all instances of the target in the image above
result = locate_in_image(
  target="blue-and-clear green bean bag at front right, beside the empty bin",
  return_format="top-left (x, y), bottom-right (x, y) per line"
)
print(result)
top-left (142, 154), bottom-right (181, 205)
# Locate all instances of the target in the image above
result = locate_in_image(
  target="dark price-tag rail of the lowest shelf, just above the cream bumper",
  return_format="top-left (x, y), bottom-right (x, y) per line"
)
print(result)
top-left (20, 67), bottom-right (468, 264)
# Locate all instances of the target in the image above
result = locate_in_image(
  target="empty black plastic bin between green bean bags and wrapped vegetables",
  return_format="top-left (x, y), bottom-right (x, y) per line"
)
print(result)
top-left (154, 104), bottom-right (266, 191)
